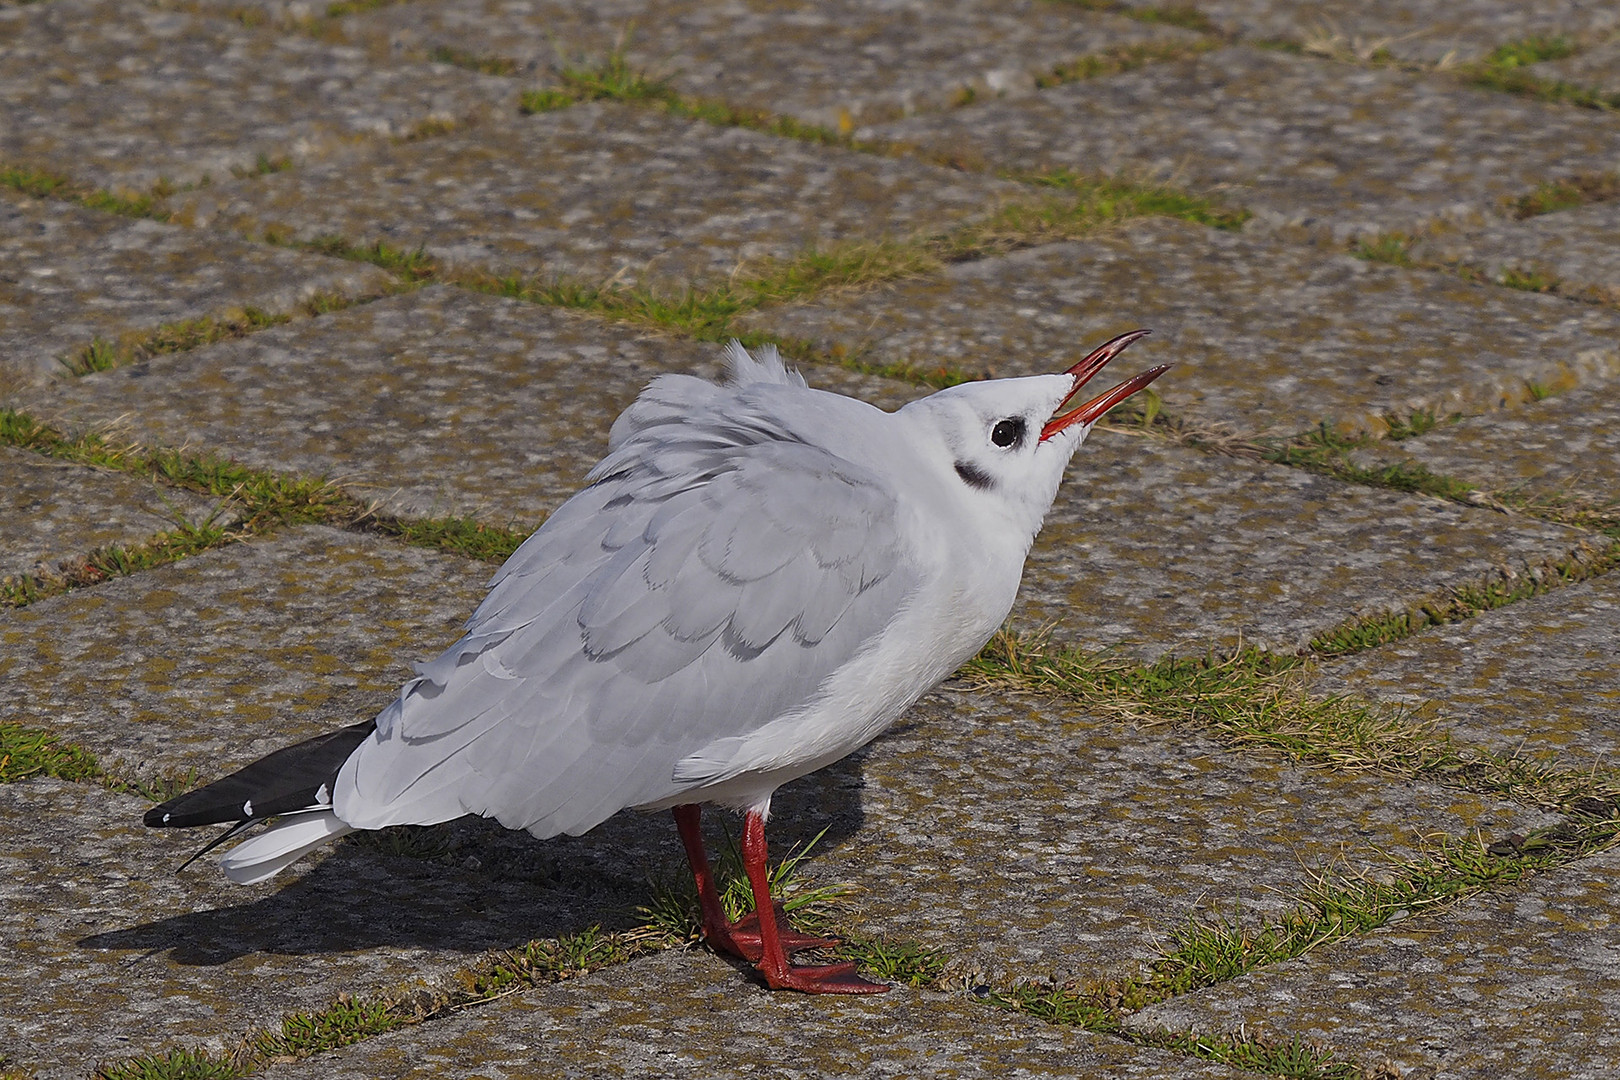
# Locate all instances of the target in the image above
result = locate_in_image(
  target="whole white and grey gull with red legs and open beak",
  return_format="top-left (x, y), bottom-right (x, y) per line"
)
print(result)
top-left (144, 330), bottom-right (1170, 994)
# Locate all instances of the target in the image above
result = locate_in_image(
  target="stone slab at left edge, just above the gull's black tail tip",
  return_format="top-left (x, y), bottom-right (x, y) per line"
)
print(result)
top-left (0, 526), bottom-right (494, 776)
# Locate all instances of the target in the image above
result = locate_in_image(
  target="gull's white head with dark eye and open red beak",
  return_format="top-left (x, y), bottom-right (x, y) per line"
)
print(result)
top-left (901, 330), bottom-right (1170, 539)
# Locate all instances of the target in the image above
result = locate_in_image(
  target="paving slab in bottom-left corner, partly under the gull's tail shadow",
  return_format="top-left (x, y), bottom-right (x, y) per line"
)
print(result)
top-left (0, 779), bottom-right (654, 1080)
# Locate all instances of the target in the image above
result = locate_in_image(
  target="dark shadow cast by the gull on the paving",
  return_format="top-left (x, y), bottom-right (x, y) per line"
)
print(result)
top-left (78, 751), bottom-right (865, 965)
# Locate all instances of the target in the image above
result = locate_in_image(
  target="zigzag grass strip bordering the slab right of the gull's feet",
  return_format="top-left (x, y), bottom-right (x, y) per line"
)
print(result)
top-left (959, 631), bottom-right (1620, 1077)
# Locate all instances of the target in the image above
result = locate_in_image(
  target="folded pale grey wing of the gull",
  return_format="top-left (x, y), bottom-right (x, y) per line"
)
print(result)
top-left (335, 442), bottom-right (917, 836)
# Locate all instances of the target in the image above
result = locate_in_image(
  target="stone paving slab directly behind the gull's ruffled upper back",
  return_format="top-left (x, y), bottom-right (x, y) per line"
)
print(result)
top-left (19, 287), bottom-right (919, 526)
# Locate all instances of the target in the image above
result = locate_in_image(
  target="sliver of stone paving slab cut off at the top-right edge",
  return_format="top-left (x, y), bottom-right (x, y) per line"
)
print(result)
top-left (1126, 0), bottom-right (1620, 62)
